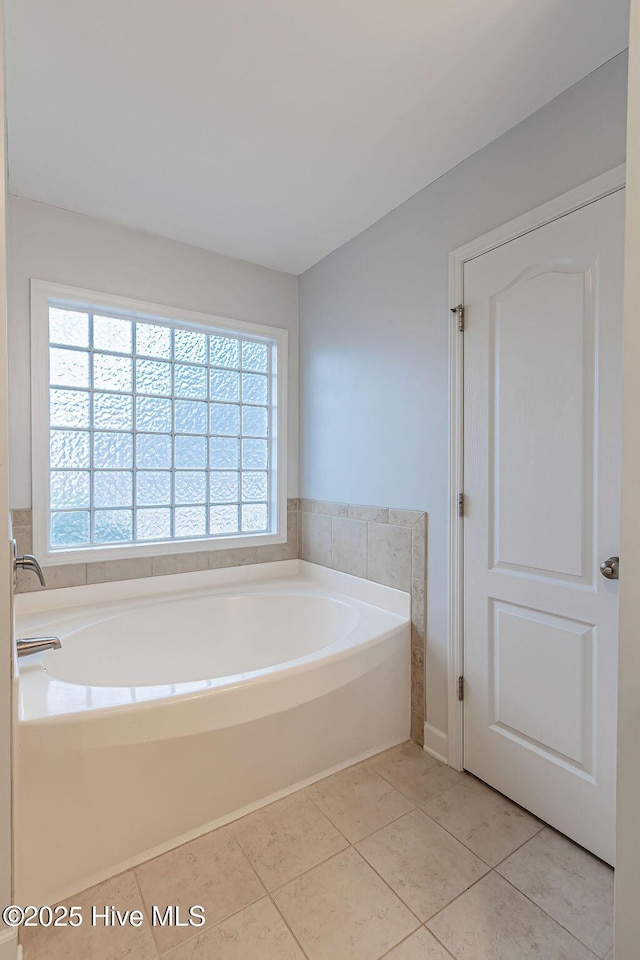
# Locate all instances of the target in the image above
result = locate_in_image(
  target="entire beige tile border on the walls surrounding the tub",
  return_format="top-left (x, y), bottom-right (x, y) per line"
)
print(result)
top-left (12, 499), bottom-right (427, 744)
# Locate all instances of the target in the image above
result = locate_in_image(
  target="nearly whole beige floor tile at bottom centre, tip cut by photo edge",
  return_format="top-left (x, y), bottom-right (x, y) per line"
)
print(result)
top-left (273, 848), bottom-right (419, 960)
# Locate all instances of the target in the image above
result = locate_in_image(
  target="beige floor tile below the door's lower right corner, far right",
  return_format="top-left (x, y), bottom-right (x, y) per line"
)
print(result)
top-left (497, 827), bottom-right (613, 957)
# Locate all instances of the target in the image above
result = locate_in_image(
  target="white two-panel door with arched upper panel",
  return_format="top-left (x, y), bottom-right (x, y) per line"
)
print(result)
top-left (464, 190), bottom-right (624, 863)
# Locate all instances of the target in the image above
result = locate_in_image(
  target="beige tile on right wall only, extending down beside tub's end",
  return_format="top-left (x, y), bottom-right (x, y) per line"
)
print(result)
top-left (298, 499), bottom-right (427, 745)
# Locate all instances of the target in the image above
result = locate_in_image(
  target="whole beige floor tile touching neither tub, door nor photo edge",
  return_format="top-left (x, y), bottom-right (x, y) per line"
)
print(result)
top-left (357, 810), bottom-right (488, 921)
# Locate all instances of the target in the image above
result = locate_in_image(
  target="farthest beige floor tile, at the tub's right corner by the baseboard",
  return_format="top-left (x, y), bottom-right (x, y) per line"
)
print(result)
top-left (369, 743), bottom-right (463, 804)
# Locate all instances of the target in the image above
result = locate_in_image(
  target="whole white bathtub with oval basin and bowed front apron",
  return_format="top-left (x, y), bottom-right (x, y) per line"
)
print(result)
top-left (14, 560), bottom-right (410, 904)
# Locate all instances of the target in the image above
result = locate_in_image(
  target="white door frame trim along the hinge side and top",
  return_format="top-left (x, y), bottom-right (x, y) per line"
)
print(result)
top-left (447, 163), bottom-right (626, 770)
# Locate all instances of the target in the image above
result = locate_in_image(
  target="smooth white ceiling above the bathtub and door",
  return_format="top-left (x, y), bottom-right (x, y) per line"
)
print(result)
top-left (6, 0), bottom-right (628, 273)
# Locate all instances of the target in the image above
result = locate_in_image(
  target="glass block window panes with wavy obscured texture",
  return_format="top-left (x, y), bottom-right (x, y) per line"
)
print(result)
top-left (42, 300), bottom-right (277, 552)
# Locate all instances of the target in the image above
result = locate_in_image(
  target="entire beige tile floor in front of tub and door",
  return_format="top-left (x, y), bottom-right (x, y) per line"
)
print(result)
top-left (22, 743), bottom-right (613, 960)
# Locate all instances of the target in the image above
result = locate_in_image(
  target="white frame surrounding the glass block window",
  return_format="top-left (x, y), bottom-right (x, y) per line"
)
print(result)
top-left (31, 279), bottom-right (288, 566)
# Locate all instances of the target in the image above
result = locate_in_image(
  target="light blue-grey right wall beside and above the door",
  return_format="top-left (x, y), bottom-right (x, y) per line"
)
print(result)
top-left (299, 54), bottom-right (627, 730)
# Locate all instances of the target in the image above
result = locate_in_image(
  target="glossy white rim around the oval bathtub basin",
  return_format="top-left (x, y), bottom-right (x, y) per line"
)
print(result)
top-left (14, 560), bottom-right (411, 747)
